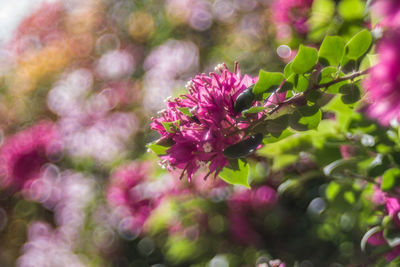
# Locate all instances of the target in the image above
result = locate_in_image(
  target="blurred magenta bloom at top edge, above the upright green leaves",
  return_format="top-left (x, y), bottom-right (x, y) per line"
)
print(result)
top-left (271, 0), bottom-right (313, 35)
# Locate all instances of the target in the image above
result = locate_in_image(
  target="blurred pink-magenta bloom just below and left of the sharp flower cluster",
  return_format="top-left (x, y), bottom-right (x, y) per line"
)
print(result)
top-left (107, 163), bottom-right (162, 236)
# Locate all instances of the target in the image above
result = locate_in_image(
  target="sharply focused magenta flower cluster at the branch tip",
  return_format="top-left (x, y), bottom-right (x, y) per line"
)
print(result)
top-left (151, 65), bottom-right (256, 180)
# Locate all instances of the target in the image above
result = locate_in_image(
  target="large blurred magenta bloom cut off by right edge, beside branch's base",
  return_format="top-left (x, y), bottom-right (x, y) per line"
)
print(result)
top-left (364, 32), bottom-right (400, 125)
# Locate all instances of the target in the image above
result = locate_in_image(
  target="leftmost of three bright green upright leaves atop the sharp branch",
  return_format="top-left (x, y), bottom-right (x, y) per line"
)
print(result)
top-left (292, 45), bottom-right (318, 74)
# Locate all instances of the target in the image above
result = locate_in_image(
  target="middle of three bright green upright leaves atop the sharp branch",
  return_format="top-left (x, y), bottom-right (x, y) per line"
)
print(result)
top-left (318, 36), bottom-right (345, 66)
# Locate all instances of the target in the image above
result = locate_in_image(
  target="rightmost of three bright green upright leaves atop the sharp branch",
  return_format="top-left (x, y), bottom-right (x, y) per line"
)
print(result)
top-left (346, 30), bottom-right (372, 60)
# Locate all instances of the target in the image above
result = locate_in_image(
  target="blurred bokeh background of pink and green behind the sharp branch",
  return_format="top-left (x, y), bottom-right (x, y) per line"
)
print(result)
top-left (0, 0), bottom-right (374, 267)
